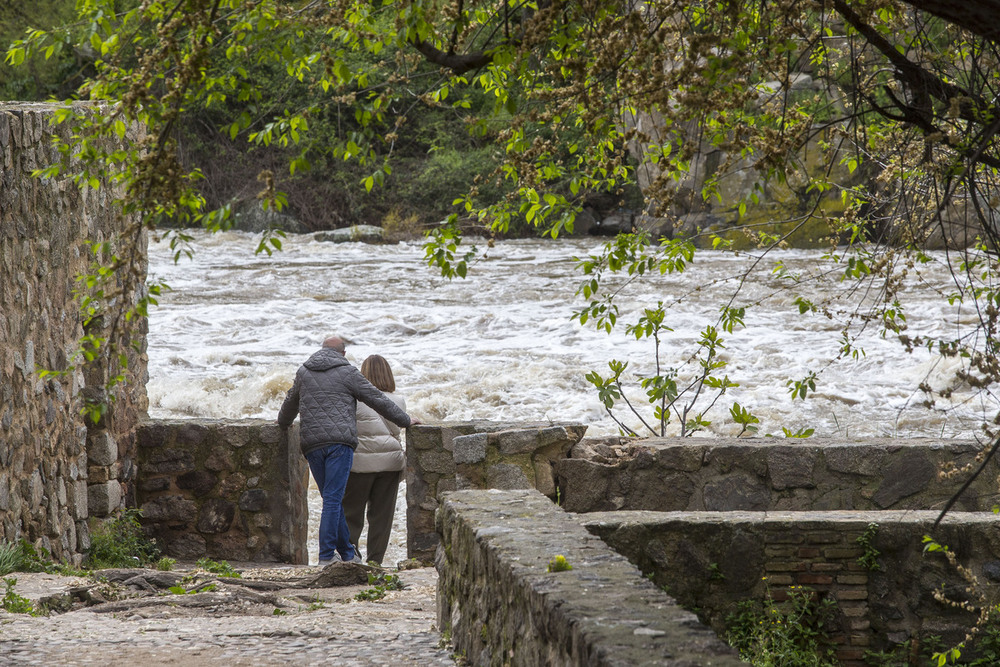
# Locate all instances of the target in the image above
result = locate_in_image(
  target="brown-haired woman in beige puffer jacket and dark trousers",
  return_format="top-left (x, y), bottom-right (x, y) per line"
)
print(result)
top-left (344, 354), bottom-right (406, 565)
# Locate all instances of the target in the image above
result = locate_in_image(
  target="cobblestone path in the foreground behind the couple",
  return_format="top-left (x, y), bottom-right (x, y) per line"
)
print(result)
top-left (0, 568), bottom-right (456, 667)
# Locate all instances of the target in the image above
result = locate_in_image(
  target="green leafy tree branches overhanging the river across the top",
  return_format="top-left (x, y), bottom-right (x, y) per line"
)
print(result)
top-left (7, 0), bottom-right (1000, 433)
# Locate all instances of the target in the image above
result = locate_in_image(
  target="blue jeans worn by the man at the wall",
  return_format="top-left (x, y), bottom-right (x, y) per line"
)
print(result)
top-left (306, 445), bottom-right (354, 561)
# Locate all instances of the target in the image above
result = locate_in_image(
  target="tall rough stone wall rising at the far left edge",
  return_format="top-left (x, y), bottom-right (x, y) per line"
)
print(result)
top-left (0, 103), bottom-right (147, 563)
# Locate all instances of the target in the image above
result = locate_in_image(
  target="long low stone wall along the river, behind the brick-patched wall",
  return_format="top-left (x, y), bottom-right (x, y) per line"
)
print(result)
top-left (554, 438), bottom-right (1000, 512)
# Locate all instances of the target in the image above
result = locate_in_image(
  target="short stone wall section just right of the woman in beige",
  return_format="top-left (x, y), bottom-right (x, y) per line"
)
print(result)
top-left (406, 421), bottom-right (587, 563)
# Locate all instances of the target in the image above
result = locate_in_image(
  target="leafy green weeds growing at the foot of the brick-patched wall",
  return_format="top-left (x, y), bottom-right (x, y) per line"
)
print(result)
top-left (726, 586), bottom-right (839, 667)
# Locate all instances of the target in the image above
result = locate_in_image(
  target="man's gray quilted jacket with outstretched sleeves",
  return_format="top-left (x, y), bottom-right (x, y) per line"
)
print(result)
top-left (278, 347), bottom-right (410, 454)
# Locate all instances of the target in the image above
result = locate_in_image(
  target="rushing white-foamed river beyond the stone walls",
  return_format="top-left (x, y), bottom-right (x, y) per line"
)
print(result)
top-left (148, 232), bottom-right (981, 563)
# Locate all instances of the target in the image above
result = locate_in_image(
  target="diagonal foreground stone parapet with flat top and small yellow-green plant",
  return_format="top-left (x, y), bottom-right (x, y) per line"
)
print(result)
top-left (436, 490), bottom-right (745, 667)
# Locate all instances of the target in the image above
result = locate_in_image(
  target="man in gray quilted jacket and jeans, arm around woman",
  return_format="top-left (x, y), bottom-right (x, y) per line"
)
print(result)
top-left (278, 336), bottom-right (420, 566)
